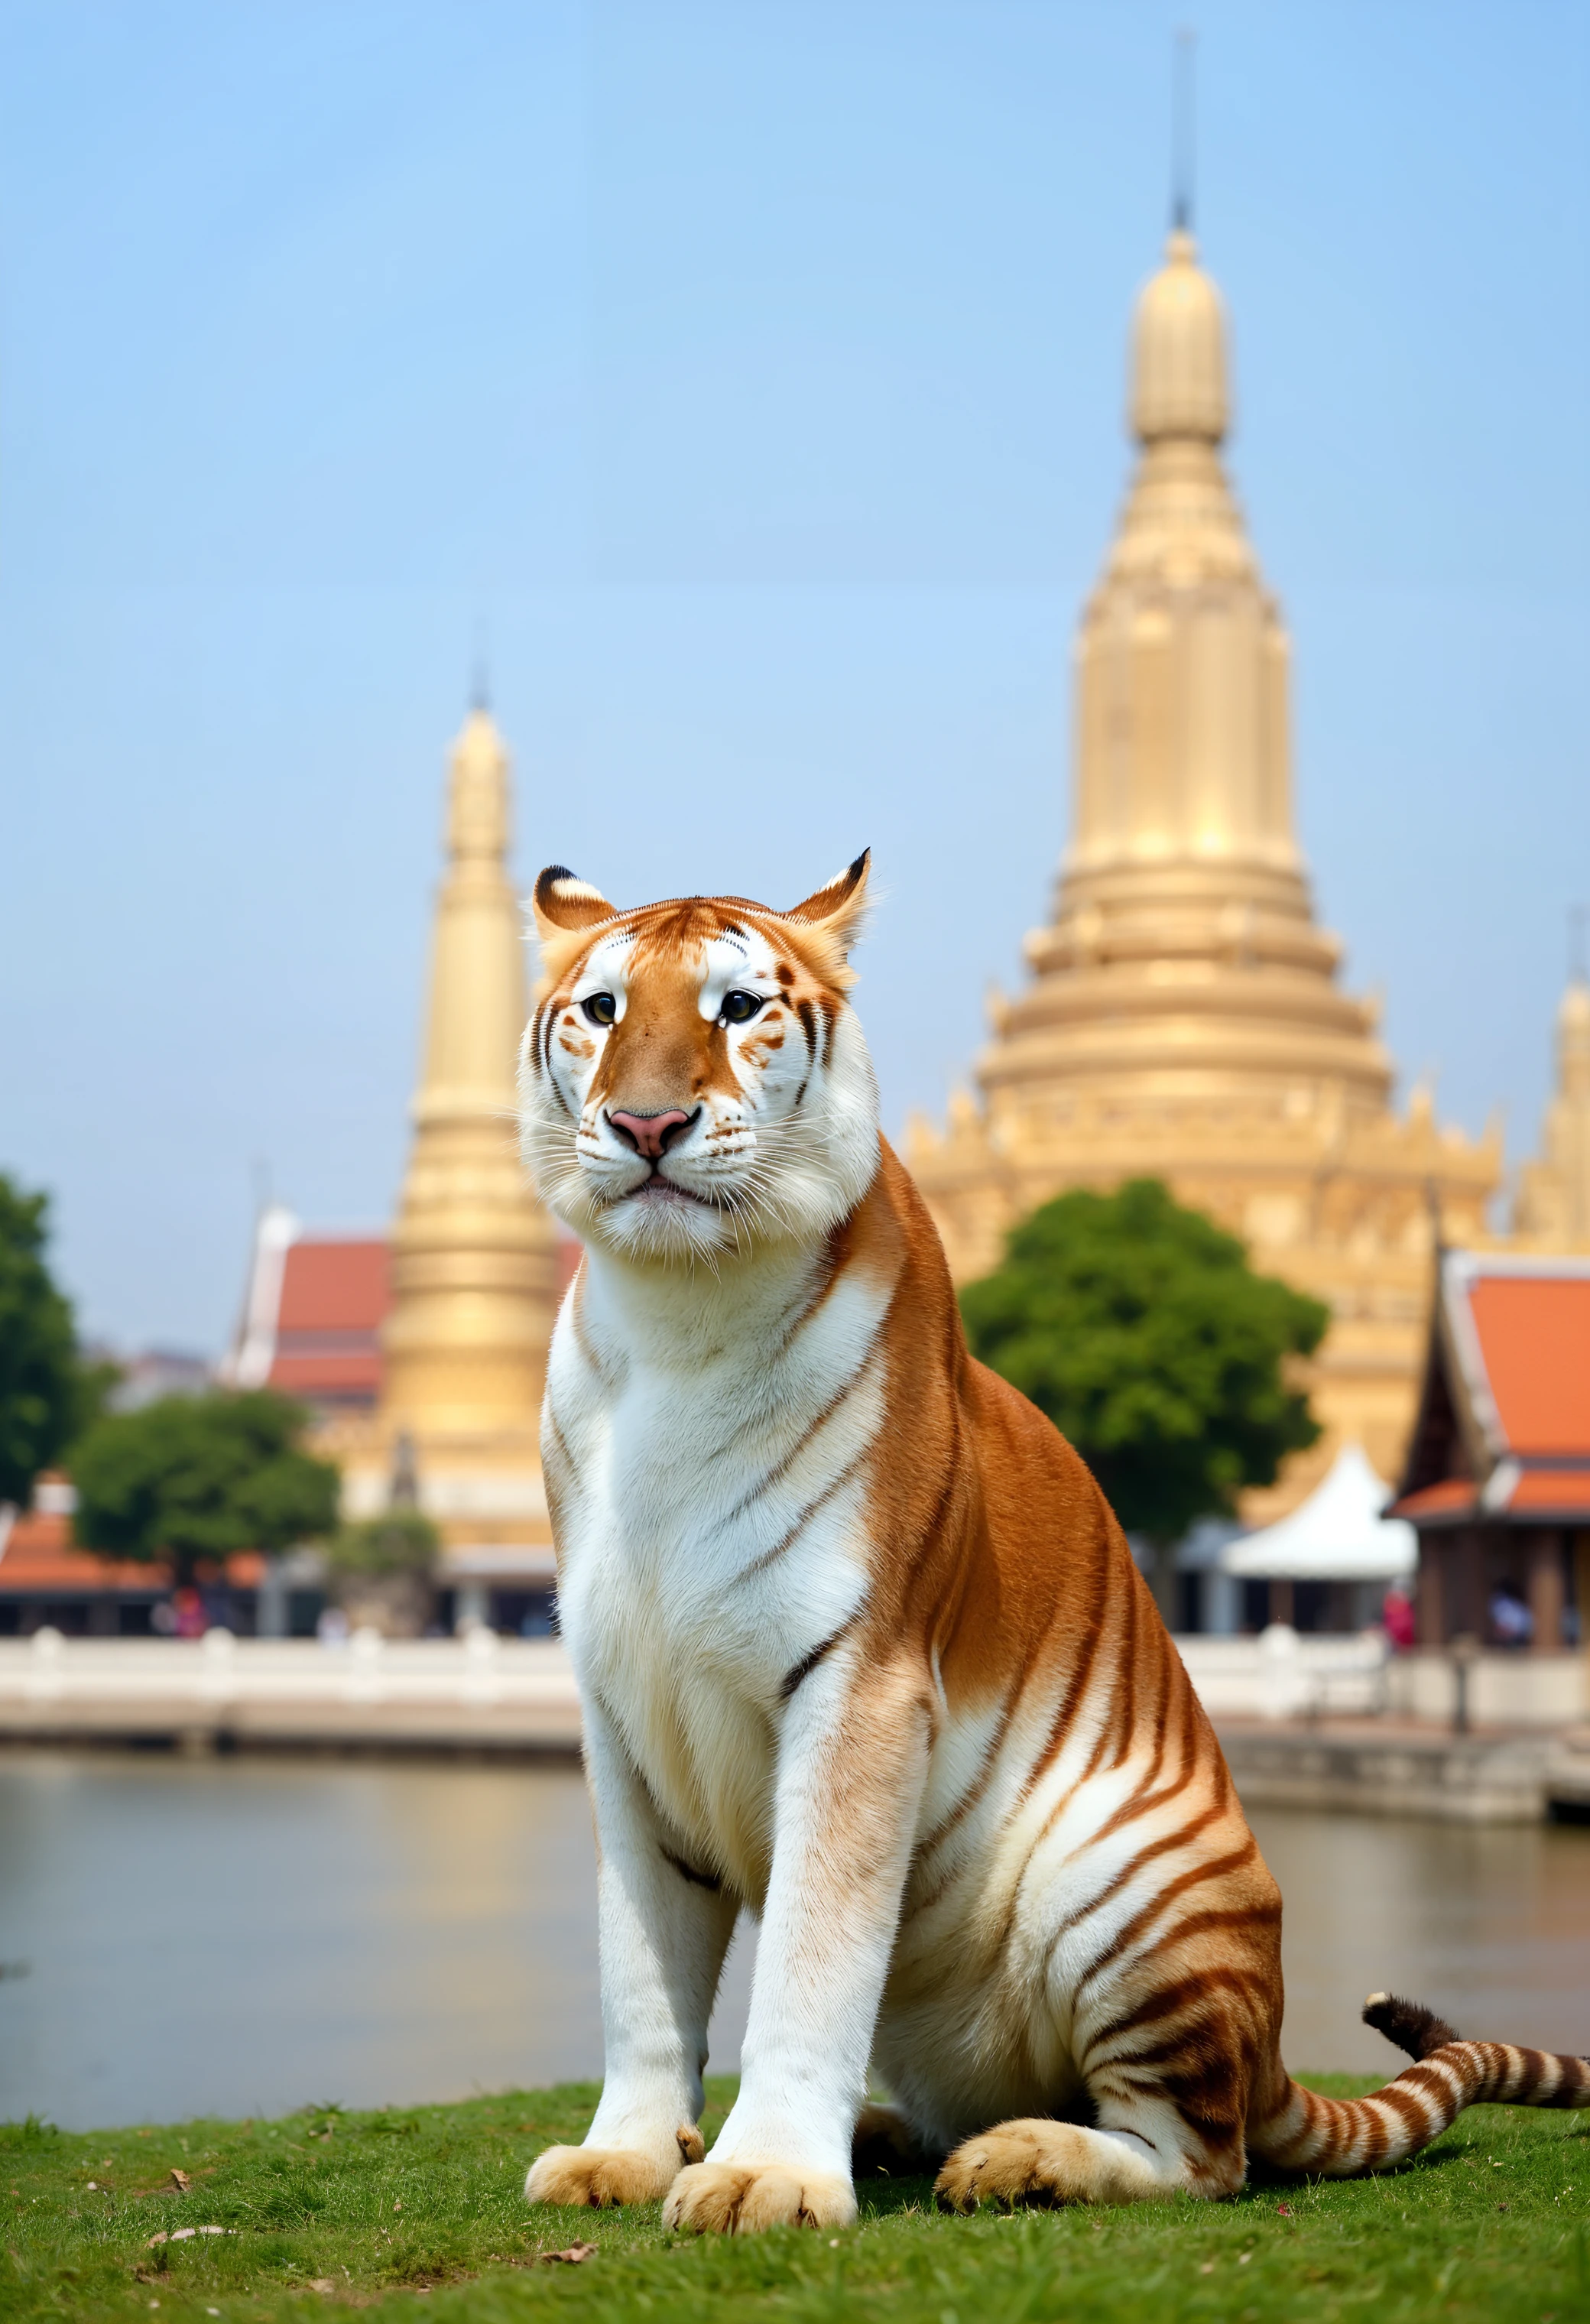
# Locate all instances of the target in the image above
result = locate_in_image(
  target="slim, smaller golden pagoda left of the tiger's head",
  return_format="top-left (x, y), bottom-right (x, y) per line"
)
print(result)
top-left (346, 706), bottom-right (558, 1585)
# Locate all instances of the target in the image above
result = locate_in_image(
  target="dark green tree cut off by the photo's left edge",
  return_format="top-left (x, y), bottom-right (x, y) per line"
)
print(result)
top-left (0, 1173), bottom-right (98, 1508)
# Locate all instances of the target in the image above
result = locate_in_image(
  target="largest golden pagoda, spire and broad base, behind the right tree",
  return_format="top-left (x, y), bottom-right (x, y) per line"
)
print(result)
top-left (909, 228), bottom-right (1501, 1520)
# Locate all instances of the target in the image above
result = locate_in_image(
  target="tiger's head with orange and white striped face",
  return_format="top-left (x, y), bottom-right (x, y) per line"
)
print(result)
top-left (518, 855), bottom-right (878, 1262)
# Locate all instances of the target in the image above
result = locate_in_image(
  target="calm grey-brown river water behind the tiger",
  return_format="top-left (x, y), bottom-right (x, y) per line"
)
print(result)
top-left (0, 1752), bottom-right (1590, 2129)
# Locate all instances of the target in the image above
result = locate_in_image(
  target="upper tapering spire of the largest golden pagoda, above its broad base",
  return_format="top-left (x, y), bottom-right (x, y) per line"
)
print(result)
top-left (925, 226), bottom-right (1393, 1137)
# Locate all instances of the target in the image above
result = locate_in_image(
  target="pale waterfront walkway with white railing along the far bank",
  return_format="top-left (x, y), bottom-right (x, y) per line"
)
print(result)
top-left (0, 1629), bottom-right (1590, 1824)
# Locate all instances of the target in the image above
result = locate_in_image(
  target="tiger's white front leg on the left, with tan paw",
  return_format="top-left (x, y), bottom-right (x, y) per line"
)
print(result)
top-left (525, 1699), bottom-right (735, 2206)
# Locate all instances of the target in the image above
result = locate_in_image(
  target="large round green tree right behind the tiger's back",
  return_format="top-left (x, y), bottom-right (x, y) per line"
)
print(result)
top-left (960, 1178), bottom-right (1329, 1613)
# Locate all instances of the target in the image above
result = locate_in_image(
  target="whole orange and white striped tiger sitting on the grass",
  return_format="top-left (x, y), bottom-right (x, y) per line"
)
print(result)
top-left (521, 858), bottom-right (1590, 2228)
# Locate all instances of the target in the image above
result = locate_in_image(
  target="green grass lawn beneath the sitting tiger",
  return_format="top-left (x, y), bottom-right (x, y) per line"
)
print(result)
top-left (0, 2078), bottom-right (1590, 2324)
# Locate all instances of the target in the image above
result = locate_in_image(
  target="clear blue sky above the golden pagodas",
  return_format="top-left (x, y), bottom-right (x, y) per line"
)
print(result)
top-left (0, 0), bottom-right (1590, 1348)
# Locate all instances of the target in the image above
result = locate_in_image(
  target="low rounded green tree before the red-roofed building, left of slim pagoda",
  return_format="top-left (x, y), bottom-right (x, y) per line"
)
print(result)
top-left (72, 1388), bottom-right (337, 1582)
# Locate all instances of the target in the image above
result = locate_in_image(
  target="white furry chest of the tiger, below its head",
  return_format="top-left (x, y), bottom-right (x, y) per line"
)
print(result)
top-left (547, 1260), bottom-right (886, 1904)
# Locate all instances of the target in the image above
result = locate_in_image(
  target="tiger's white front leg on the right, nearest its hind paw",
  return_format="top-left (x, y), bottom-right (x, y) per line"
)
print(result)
top-left (663, 1652), bottom-right (930, 2233)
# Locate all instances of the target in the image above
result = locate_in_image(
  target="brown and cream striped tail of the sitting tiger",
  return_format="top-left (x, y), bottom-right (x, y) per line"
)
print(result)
top-left (1248, 1994), bottom-right (1590, 2177)
